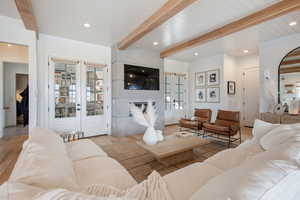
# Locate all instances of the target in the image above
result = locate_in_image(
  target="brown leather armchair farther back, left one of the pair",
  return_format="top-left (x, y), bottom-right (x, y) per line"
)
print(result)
top-left (179, 109), bottom-right (212, 131)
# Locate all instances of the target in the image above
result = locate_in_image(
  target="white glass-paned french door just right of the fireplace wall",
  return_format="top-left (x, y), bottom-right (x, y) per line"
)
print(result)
top-left (165, 73), bottom-right (187, 124)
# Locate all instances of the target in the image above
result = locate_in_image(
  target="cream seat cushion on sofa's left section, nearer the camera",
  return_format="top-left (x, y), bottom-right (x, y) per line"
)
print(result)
top-left (73, 157), bottom-right (137, 189)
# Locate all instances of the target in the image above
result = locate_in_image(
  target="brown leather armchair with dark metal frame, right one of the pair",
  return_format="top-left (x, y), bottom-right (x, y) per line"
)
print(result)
top-left (202, 110), bottom-right (242, 147)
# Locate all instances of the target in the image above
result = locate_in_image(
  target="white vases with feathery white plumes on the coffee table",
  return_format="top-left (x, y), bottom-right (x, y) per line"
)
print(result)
top-left (130, 101), bottom-right (164, 145)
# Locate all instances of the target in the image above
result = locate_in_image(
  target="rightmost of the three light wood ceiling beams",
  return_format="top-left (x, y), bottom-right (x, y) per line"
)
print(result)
top-left (160, 0), bottom-right (300, 58)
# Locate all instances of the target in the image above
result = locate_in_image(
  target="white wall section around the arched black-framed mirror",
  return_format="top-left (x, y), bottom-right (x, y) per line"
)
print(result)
top-left (259, 34), bottom-right (300, 112)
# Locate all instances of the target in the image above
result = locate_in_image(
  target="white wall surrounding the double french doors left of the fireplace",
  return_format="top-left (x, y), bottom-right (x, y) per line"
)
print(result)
top-left (38, 34), bottom-right (111, 131)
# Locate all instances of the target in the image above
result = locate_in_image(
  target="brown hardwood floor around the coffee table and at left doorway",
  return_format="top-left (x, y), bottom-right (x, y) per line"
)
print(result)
top-left (0, 125), bottom-right (251, 184)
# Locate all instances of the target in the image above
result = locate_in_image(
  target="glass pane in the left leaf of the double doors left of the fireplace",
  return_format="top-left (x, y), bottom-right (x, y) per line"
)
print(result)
top-left (54, 63), bottom-right (77, 118)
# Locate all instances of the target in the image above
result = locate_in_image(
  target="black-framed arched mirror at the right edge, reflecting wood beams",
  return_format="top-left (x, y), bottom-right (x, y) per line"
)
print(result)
top-left (278, 47), bottom-right (300, 105)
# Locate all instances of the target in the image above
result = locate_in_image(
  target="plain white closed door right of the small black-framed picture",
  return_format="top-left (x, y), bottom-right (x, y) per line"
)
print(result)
top-left (242, 67), bottom-right (260, 127)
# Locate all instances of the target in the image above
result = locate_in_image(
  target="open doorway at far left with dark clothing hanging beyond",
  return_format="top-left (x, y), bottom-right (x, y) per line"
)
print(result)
top-left (0, 43), bottom-right (29, 137)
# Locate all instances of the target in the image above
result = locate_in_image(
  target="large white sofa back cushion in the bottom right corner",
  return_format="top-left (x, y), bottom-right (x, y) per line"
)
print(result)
top-left (191, 159), bottom-right (300, 200)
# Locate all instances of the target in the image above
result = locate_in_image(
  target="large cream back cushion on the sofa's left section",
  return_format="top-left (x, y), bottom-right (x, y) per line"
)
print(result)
top-left (10, 128), bottom-right (78, 190)
